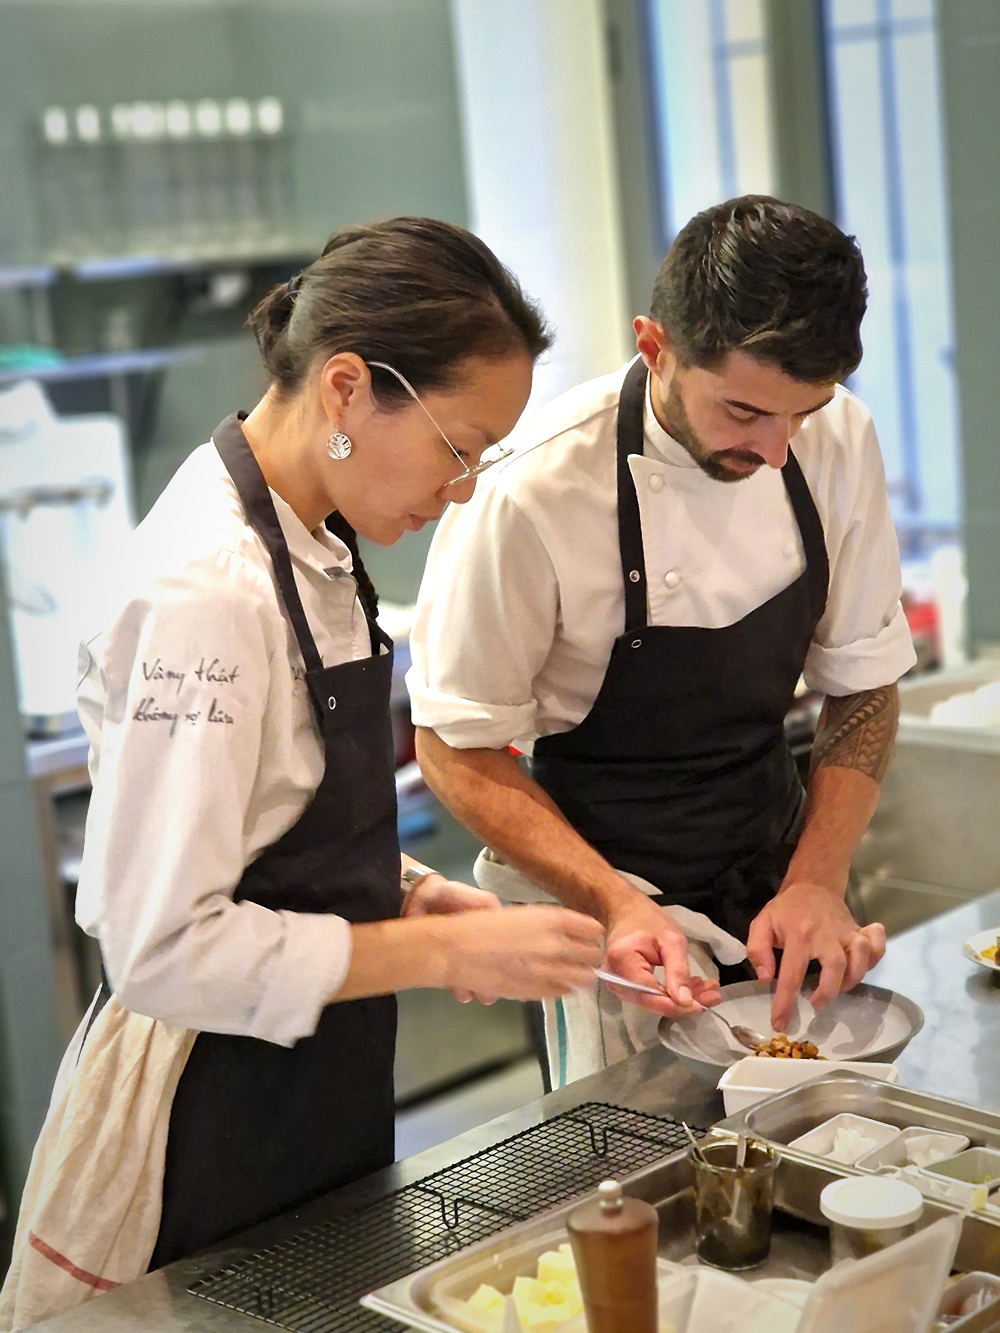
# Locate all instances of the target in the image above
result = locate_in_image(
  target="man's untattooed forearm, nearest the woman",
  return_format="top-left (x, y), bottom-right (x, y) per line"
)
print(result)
top-left (416, 726), bottom-right (637, 924)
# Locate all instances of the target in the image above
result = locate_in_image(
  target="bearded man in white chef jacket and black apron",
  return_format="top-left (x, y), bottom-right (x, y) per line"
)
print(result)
top-left (407, 196), bottom-right (915, 1082)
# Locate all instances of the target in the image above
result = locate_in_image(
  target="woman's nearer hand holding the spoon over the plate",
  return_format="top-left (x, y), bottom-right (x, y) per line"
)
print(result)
top-left (440, 906), bottom-right (604, 1000)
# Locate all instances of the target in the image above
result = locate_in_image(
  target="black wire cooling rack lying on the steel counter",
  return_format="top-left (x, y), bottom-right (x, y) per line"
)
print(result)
top-left (188, 1102), bottom-right (704, 1333)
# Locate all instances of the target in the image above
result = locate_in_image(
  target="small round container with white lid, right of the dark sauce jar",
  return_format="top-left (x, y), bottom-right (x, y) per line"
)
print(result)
top-left (820, 1176), bottom-right (924, 1264)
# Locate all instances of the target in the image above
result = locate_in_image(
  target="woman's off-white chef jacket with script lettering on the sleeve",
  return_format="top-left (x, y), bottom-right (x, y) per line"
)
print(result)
top-left (76, 443), bottom-right (371, 1045)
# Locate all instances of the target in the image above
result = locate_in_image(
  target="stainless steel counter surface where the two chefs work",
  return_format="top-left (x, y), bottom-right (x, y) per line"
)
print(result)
top-left (27, 890), bottom-right (1000, 1333)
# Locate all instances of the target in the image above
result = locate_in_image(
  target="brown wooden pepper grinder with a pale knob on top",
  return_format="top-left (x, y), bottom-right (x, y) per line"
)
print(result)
top-left (567, 1180), bottom-right (657, 1333)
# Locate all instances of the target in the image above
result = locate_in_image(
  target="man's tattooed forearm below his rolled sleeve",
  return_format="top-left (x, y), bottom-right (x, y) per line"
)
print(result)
top-left (784, 684), bottom-right (899, 893)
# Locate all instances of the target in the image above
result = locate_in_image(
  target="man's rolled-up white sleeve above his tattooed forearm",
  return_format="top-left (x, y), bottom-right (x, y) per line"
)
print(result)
top-left (803, 405), bottom-right (916, 696)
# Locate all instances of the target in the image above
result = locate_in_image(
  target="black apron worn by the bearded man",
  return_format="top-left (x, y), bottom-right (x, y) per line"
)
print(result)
top-left (532, 361), bottom-right (829, 941)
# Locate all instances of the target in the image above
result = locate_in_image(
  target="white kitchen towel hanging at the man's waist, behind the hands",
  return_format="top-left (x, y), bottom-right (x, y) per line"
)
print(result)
top-left (473, 848), bottom-right (747, 1088)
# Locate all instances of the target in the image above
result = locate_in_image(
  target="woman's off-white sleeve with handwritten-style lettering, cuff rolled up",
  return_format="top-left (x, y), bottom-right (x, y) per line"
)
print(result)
top-left (77, 556), bottom-right (351, 1045)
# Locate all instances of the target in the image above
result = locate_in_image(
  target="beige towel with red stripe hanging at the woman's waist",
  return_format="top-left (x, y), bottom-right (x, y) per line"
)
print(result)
top-left (0, 996), bottom-right (197, 1333)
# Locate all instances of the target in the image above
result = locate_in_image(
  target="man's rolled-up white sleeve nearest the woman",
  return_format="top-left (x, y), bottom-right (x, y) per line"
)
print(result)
top-left (407, 488), bottom-right (559, 749)
